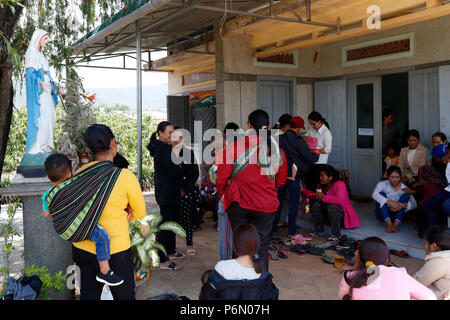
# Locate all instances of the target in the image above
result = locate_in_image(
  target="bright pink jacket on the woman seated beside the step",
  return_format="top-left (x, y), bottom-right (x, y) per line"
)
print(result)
top-left (322, 181), bottom-right (361, 229)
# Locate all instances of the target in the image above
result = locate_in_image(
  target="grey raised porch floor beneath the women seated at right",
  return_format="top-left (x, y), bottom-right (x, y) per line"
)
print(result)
top-left (297, 201), bottom-right (425, 259)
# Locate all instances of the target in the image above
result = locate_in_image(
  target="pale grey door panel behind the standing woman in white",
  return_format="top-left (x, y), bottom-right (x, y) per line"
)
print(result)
top-left (314, 80), bottom-right (348, 170)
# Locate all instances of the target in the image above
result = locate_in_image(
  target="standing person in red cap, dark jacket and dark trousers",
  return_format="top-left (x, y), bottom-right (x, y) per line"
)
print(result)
top-left (272, 116), bottom-right (319, 237)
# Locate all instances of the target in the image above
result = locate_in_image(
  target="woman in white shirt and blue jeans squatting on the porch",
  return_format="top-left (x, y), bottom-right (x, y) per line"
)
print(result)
top-left (372, 166), bottom-right (417, 232)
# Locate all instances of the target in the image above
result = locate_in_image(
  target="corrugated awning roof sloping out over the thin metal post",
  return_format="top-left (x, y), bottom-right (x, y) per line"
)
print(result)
top-left (74, 0), bottom-right (267, 55)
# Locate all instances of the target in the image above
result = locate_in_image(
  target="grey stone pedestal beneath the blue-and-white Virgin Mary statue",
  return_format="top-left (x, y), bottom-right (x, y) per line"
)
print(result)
top-left (0, 176), bottom-right (74, 300)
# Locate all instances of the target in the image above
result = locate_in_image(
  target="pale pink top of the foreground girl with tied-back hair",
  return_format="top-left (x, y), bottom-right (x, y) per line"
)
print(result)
top-left (338, 266), bottom-right (436, 300)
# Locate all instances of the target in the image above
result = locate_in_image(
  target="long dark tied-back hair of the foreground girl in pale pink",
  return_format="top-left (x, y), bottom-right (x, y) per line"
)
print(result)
top-left (342, 237), bottom-right (389, 300)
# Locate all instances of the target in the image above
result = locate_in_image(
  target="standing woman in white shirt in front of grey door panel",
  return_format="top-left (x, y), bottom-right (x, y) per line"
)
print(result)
top-left (306, 111), bottom-right (333, 164)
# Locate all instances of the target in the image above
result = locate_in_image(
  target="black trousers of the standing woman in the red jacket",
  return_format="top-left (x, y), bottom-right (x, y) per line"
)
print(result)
top-left (227, 202), bottom-right (276, 270)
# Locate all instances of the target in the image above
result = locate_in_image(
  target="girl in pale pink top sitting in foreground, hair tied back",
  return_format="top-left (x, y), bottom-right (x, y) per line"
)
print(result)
top-left (338, 237), bottom-right (436, 300)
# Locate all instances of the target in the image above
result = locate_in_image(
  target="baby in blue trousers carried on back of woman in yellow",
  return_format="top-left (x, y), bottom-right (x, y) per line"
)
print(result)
top-left (42, 153), bottom-right (126, 286)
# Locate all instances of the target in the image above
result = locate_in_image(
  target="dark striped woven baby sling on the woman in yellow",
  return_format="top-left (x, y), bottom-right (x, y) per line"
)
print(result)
top-left (46, 161), bottom-right (121, 242)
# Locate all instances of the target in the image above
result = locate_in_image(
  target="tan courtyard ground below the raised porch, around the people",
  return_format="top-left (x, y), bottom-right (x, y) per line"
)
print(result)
top-left (0, 194), bottom-right (423, 300)
